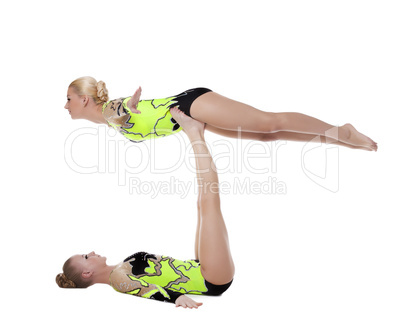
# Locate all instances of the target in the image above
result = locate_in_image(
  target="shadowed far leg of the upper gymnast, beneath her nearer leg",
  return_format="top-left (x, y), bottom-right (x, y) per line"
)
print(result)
top-left (205, 125), bottom-right (365, 149)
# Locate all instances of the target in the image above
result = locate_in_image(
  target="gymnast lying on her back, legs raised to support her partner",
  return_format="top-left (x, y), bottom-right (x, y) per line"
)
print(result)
top-left (56, 107), bottom-right (235, 308)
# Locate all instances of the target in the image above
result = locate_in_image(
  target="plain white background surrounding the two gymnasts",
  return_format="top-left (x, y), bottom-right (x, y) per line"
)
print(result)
top-left (0, 0), bottom-right (402, 317)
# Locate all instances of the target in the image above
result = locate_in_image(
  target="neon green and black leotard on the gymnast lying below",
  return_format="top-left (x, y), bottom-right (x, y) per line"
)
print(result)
top-left (110, 252), bottom-right (232, 303)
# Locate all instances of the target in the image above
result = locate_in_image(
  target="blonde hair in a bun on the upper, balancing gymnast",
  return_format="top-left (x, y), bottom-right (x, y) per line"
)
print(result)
top-left (69, 76), bottom-right (109, 104)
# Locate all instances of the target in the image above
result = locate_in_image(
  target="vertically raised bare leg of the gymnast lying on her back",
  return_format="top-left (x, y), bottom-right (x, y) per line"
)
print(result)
top-left (170, 109), bottom-right (234, 285)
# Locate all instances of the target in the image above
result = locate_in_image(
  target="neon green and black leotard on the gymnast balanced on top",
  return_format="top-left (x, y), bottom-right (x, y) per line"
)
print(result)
top-left (102, 88), bottom-right (211, 142)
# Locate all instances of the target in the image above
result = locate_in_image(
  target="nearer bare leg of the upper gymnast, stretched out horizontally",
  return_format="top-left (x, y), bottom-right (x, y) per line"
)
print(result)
top-left (191, 92), bottom-right (377, 150)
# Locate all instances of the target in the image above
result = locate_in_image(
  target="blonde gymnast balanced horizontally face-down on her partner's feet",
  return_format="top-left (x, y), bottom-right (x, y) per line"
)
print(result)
top-left (65, 76), bottom-right (377, 151)
